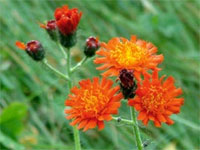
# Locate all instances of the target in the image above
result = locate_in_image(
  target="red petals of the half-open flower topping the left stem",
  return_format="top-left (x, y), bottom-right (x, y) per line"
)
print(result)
top-left (54, 5), bottom-right (82, 35)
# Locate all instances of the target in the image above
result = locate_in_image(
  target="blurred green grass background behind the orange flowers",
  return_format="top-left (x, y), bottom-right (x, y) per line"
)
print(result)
top-left (0, 0), bottom-right (200, 150)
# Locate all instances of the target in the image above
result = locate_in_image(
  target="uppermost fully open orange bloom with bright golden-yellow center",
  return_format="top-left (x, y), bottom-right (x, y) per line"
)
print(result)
top-left (94, 36), bottom-right (163, 80)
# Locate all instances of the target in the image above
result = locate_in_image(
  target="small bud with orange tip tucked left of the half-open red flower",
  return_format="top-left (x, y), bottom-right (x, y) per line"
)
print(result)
top-left (40, 20), bottom-right (58, 41)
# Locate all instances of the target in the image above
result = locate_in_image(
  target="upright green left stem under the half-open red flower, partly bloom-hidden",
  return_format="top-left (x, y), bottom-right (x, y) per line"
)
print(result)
top-left (67, 49), bottom-right (81, 150)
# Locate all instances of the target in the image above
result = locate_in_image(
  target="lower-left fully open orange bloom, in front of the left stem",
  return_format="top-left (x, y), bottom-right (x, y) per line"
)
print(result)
top-left (65, 77), bottom-right (122, 131)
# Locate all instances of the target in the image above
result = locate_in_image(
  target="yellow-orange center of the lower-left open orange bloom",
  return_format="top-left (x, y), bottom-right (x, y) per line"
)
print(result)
top-left (81, 86), bottom-right (109, 116)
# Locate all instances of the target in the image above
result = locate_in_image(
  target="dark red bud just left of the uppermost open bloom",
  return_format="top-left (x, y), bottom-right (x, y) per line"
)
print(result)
top-left (84, 36), bottom-right (100, 57)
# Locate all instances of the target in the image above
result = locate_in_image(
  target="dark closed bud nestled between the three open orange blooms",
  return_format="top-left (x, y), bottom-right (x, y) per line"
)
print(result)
top-left (119, 69), bottom-right (137, 99)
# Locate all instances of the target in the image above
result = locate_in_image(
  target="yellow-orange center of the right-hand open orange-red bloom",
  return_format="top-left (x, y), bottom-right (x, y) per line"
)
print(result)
top-left (142, 85), bottom-right (166, 112)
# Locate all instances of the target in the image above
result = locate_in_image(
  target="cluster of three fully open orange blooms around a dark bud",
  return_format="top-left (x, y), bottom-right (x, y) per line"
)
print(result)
top-left (62, 6), bottom-right (184, 131)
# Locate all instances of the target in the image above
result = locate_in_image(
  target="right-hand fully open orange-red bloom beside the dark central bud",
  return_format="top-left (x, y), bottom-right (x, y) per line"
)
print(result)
top-left (128, 70), bottom-right (184, 127)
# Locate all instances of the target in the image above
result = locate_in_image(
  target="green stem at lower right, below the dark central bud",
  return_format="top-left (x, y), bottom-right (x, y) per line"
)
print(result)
top-left (130, 107), bottom-right (143, 150)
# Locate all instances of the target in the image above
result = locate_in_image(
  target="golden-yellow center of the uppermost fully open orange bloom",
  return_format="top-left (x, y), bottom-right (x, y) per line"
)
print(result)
top-left (110, 42), bottom-right (147, 69)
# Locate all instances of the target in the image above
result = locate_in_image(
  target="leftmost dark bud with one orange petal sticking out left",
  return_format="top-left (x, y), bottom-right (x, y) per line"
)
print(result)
top-left (15, 40), bottom-right (45, 61)
